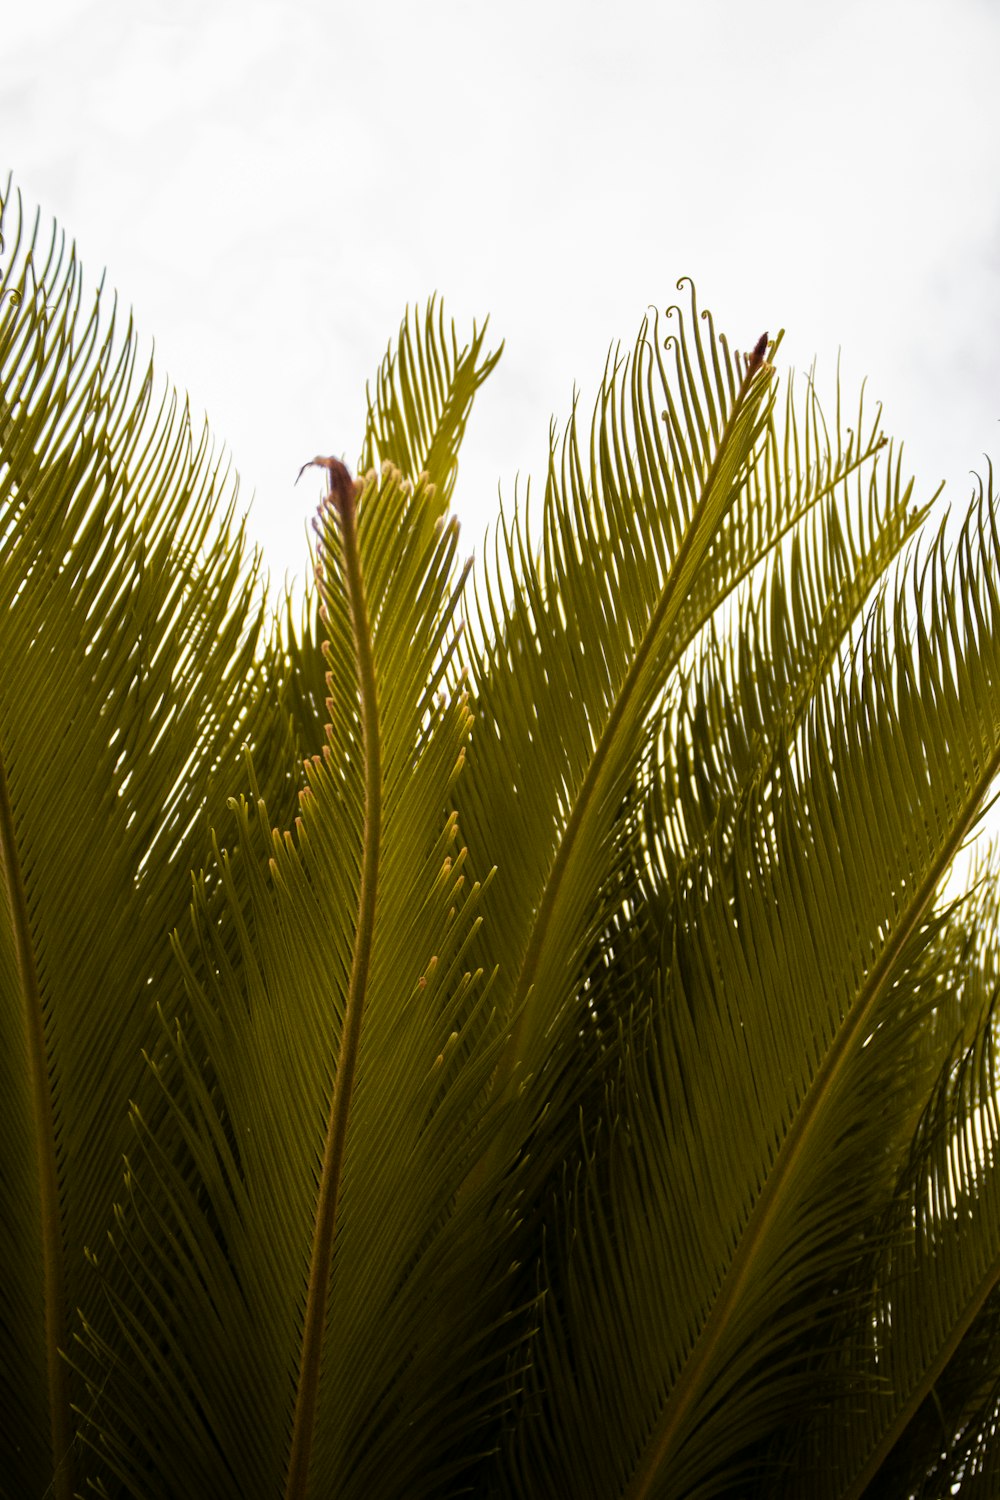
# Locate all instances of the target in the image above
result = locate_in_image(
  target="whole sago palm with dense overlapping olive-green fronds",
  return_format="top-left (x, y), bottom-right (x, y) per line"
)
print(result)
top-left (0, 178), bottom-right (1000, 1500)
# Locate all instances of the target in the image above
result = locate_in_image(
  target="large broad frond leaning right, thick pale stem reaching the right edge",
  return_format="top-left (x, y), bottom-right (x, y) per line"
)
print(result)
top-left (500, 503), bottom-right (1000, 1500)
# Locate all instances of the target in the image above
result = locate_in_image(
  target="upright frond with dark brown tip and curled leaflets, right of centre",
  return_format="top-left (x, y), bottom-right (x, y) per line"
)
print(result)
top-left (460, 298), bottom-right (771, 1128)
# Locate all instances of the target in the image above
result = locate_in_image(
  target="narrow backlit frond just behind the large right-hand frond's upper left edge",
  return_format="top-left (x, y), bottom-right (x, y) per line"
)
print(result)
top-left (586, 429), bottom-right (928, 1086)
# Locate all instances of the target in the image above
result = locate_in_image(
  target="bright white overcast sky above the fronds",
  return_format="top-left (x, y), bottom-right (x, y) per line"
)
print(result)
top-left (0, 0), bottom-right (1000, 597)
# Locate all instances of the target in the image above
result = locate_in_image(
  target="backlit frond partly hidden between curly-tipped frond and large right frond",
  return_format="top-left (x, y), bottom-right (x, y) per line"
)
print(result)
top-left (643, 429), bottom-right (933, 872)
